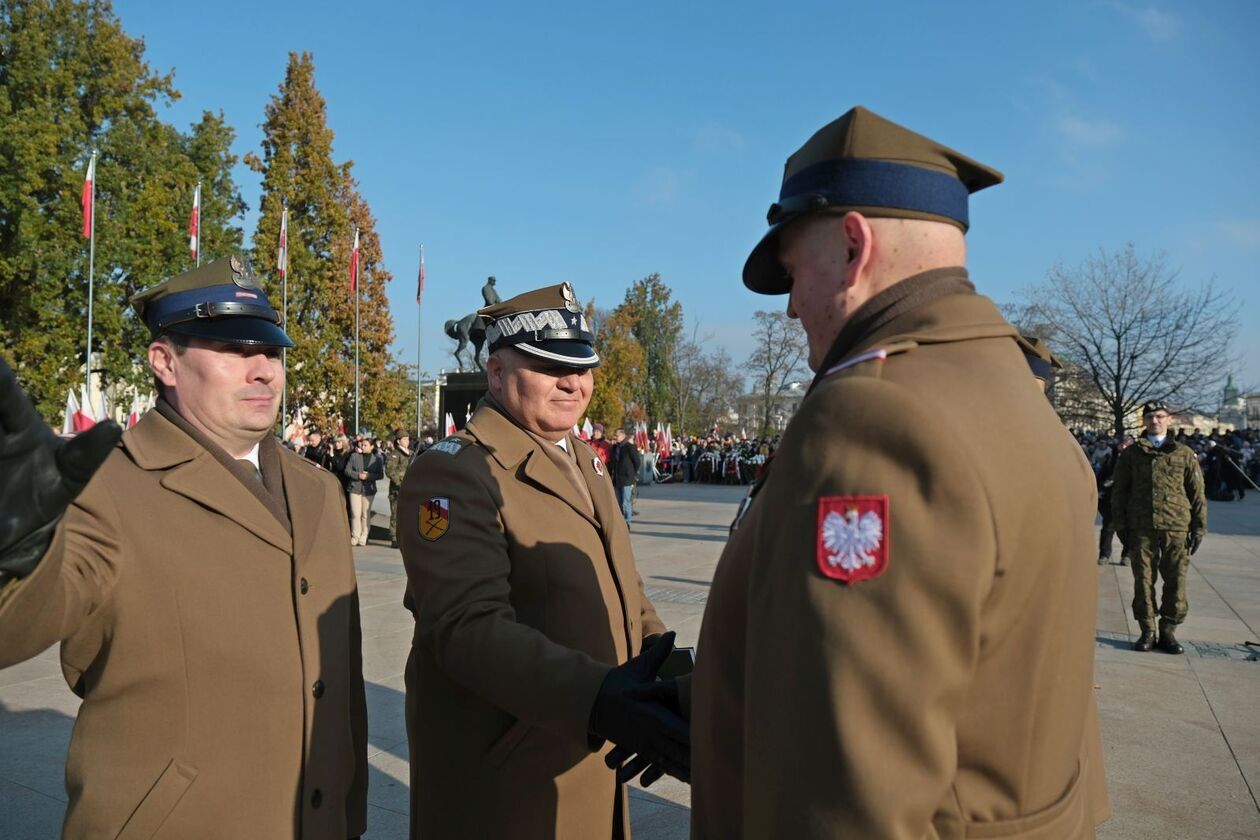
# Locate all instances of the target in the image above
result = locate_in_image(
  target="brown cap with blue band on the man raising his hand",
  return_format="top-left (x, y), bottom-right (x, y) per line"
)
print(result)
top-left (131, 254), bottom-right (294, 348)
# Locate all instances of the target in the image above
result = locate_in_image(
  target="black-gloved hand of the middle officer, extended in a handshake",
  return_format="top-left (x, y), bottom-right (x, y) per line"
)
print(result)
top-left (590, 632), bottom-right (690, 781)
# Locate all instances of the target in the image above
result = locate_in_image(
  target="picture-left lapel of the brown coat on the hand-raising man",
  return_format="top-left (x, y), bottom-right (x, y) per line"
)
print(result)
top-left (122, 412), bottom-right (292, 553)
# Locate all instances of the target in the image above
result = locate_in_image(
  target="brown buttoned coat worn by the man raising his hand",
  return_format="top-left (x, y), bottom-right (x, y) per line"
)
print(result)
top-left (0, 412), bottom-right (367, 840)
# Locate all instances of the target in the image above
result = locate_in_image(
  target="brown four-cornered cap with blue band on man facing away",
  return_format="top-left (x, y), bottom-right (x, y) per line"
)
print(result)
top-left (743, 106), bottom-right (1002, 295)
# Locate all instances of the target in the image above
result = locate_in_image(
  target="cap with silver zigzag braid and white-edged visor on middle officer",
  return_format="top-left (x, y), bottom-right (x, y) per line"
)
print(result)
top-left (476, 283), bottom-right (600, 368)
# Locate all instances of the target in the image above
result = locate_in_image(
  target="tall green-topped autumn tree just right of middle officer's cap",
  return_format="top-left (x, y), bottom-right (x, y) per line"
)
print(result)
top-left (616, 273), bottom-right (683, 423)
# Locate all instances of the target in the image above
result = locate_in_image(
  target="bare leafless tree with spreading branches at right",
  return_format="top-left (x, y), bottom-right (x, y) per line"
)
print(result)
top-left (1023, 244), bottom-right (1237, 434)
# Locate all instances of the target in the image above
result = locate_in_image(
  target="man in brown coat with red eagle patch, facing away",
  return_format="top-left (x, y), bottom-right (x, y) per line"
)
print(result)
top-left (690, 108), bottom-right (1106, 840)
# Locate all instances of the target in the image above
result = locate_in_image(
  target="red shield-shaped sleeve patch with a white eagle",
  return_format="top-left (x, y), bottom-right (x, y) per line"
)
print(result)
top-left (818, 496), bottom-right (888, 583)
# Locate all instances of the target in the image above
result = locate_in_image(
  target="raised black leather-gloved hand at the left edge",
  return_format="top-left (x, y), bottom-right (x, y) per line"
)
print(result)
top-left (0, 359), bottom-right (122, 584)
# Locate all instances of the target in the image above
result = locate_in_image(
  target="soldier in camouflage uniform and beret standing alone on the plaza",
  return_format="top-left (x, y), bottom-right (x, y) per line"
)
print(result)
top-left (1111, 402), bottom-right (1207, 654)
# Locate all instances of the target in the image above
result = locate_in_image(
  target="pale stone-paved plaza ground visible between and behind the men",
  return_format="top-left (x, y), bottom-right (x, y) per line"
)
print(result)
top-left (0, 482), bottom-right (1260, 840)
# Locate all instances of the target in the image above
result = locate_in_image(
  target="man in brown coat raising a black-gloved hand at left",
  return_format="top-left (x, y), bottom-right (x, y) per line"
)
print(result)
top-left (0, 257), bottom-right (367, 840)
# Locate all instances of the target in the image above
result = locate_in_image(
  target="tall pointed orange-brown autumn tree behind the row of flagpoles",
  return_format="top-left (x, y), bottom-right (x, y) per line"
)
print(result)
top-left (246, 53), bottom-right (415, 433)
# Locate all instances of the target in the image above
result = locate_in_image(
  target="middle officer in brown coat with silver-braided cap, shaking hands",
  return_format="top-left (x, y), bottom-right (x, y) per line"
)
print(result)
top-left (398, 283), bottom-right (687, 840)
